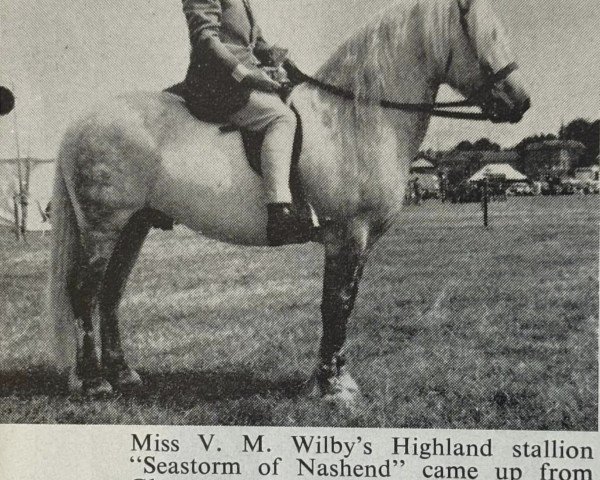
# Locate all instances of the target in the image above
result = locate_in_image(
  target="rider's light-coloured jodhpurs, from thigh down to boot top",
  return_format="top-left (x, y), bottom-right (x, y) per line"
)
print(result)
top-left (229, 91), bottom-right (296, 203)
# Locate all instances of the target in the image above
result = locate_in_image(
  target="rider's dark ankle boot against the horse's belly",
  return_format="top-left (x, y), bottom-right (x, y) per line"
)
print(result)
top-left (267, 203), bottom-right (318, 247)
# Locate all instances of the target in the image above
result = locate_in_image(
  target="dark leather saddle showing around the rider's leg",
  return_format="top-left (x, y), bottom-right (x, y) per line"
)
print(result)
top-left (164, 82), bottom-right (312, 223)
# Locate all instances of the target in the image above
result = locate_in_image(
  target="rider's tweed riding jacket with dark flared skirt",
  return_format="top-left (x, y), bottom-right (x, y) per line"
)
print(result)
top-left (183, 0), bottom-right (270, 121)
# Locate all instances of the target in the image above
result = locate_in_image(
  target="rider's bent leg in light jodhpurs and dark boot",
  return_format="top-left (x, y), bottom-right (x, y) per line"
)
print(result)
top-left (230, 92), bottom-right (312, 245)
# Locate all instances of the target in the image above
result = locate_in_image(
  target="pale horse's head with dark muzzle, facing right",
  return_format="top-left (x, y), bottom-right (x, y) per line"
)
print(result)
top-left (444, 0), bottom-right (530, 123)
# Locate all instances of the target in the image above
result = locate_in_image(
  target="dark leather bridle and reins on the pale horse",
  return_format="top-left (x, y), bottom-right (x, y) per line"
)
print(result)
top-left (296, 0), bottom-right (518, 121)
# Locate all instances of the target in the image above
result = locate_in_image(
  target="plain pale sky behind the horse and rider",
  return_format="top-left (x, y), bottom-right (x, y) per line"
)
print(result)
top-left (0, 0), bottom-right (600, 158)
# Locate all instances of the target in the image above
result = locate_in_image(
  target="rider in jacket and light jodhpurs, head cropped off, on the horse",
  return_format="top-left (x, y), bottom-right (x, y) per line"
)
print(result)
top-left (183, 0), bottom-right (313, 245)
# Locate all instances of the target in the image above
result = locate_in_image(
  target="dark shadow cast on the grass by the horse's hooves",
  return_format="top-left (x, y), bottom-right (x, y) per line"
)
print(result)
top-left (0, 367), bottom-right (306, 408)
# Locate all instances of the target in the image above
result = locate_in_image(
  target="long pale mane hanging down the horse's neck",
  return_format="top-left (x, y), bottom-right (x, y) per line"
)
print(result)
top-left (300, 0), bottom-right (455, 192)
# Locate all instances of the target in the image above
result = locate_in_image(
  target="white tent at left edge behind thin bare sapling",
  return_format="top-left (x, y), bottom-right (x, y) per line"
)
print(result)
top-left (0, 158), bottom-right (54, 231)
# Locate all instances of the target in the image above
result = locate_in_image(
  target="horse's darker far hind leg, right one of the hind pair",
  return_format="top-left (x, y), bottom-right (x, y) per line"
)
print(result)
top-left (98, 210), bottom-right (150, 390)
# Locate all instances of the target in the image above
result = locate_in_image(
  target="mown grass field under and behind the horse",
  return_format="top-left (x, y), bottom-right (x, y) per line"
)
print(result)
top-left (0, 197), bottom-right (600, 430)
